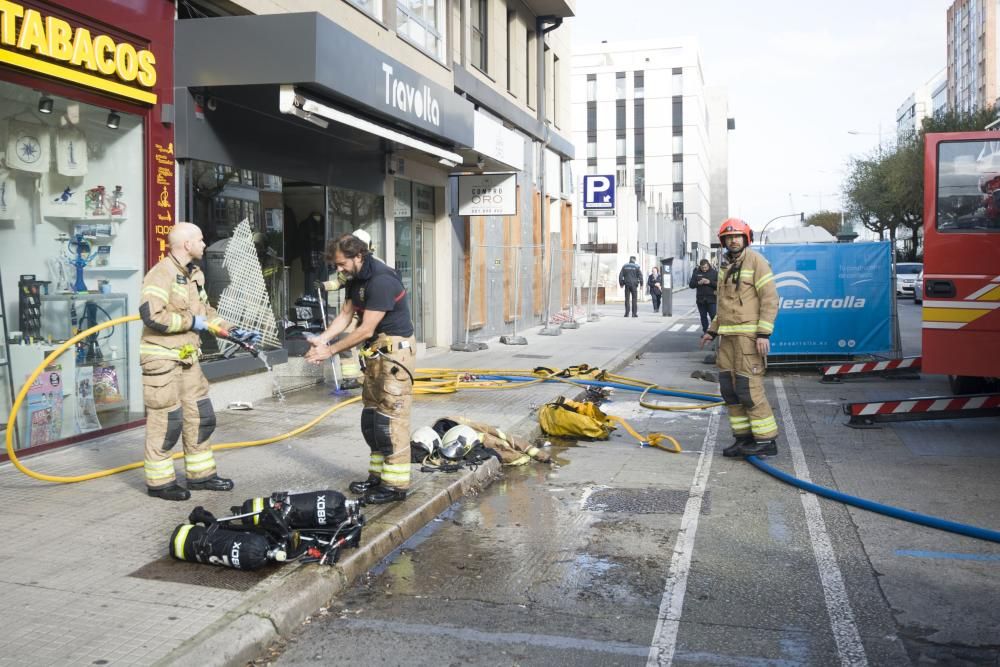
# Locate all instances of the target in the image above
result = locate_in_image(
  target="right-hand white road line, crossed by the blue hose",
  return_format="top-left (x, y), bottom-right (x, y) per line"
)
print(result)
top-left (774, 378), bottom-right (868, 667)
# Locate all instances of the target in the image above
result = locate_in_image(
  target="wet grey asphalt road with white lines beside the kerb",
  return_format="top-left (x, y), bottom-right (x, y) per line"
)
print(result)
top-left (262, 299), bottom-right (1000, 666)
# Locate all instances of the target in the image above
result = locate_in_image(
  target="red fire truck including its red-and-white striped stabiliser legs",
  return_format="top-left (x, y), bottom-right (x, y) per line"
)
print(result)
top-left (836, 132), bottom-right (1000, 428)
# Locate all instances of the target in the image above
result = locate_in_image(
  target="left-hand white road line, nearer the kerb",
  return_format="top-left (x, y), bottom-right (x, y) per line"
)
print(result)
top-left (646, 410), bottom-right (719, 667)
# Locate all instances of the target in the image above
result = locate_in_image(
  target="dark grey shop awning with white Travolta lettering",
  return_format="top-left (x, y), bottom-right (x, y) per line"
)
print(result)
top-left (175, 12), bottom-right (474, 170)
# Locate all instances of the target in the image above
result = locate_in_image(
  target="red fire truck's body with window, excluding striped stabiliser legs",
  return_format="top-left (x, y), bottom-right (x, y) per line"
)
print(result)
top-left (922, 131), bottom-right (1000, 394)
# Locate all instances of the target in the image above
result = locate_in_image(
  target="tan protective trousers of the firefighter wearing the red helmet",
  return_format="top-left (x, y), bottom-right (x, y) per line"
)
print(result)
top-left (716, 335), bottom-right (778, 440)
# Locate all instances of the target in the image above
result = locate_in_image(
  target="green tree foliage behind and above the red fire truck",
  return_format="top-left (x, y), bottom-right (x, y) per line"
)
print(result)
top-left (844, 107), bottom-right (997, 260)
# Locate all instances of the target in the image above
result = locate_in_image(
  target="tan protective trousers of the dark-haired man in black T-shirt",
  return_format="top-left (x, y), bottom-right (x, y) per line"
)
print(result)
top-left (361, 334), bottom-right (417, 489)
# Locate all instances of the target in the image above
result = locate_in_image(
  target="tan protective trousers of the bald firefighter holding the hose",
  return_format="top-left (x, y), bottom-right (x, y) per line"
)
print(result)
top-left (142, 356), bottom-right (215, 489)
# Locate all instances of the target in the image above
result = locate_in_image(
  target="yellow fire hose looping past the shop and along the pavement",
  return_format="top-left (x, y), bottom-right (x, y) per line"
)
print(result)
top-left (6, 315), bottom-right (722, 484)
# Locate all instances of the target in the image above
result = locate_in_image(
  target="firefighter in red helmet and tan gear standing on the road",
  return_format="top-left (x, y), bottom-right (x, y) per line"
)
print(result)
top-left (701, 218), bottom-right (778, 456)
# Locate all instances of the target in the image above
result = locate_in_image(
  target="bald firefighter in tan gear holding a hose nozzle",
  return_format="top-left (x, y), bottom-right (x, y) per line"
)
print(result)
top-left (139, 222), bottom-right (261, 500)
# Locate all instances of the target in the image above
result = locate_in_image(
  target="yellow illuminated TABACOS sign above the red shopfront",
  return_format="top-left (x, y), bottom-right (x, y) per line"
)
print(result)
top-left (0, 0), bottom-right (156, 104)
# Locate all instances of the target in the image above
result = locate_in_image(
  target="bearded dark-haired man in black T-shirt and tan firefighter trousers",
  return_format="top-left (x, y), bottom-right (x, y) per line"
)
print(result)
top-left (306, 234), bottom-right (416, 504)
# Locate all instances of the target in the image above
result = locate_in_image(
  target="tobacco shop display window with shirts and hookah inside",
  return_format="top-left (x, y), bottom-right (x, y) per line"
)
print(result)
top-left (0, 82), bottom-right (146, 449)
